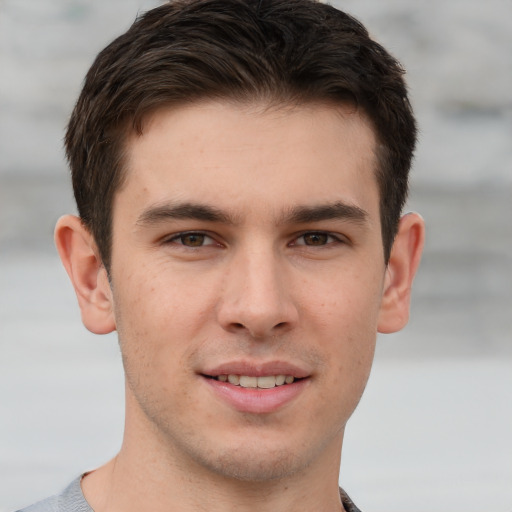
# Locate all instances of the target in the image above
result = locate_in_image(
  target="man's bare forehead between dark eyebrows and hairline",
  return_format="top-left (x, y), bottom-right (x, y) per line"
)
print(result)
top-left (118, 101), bottom-right (378, 224)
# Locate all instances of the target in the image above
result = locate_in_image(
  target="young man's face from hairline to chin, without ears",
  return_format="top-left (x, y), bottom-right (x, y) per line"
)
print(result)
top-left (107, 103), bottom-right (386, 480)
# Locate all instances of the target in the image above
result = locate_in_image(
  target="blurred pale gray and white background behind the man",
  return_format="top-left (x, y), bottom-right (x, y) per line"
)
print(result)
top-left (0, 0), bottom-right (512, 512)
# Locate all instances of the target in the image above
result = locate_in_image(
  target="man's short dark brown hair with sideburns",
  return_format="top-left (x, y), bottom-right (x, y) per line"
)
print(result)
top-left (65, 0), bottom-right (416, 270)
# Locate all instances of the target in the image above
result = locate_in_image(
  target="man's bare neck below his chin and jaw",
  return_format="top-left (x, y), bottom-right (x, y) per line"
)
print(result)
top-left (82, 390), bottom-right (343, 512)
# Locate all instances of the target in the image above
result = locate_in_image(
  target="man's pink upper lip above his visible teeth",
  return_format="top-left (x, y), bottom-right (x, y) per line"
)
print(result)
top-left (201, 361), bottom-right (310, 379)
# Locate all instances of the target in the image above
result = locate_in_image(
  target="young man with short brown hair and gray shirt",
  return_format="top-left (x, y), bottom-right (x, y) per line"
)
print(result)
top-left (18, 0), bottom-right (424, 512)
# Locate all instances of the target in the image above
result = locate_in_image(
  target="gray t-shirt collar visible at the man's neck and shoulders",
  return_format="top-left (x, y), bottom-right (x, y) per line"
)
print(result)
top-left (17, 476), bottom-right (361, 512)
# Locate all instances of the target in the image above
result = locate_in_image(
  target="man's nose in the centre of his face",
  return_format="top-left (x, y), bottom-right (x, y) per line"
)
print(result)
top-left (218, 248), bottom-right (299, 339)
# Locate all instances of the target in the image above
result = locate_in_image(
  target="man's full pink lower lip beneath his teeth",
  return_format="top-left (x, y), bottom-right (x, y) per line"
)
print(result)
top-left (203, 377), bottom-right (309, 414)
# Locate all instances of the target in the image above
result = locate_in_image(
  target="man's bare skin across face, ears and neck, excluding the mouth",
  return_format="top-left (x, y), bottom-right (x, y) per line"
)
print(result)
top-left (56, 102), bottom-right (424, 512)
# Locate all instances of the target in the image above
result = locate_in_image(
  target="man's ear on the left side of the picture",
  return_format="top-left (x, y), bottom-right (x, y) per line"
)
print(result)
top-left (55, 215), bottom-right (116, 334)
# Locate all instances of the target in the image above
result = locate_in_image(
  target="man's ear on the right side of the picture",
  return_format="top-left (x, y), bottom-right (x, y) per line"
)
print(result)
top-left (377, 213), bottom-right (425, 334)
